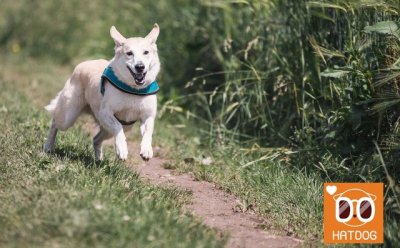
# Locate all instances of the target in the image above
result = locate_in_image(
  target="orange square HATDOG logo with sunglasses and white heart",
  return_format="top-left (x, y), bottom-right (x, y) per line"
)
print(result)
top-left (324, 183), bottom-right (383, 244)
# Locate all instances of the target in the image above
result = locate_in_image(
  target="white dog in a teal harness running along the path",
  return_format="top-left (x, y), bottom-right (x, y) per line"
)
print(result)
top-left (43, 24), bottom-right (160, 161)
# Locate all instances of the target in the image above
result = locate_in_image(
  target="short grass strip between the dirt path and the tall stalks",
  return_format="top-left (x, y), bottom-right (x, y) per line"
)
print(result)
top-left (157, 118), bottom-right (324, 241)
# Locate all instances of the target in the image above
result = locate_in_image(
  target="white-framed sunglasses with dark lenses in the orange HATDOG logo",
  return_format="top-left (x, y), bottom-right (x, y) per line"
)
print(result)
top-left (333, 189), bottom-right (376, 224)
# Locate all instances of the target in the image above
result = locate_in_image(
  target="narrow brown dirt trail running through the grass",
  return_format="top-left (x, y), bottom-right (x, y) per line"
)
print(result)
top-left (92, 129), bottom-right (302, 248)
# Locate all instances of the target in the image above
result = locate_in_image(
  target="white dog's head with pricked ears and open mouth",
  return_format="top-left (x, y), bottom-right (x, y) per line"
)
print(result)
top-left (110, 24), bottom-right (160, 88)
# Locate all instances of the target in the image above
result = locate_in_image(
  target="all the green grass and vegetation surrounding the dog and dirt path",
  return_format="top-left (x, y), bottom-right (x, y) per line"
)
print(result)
top-left (0, 0), bottom-right (400, 247)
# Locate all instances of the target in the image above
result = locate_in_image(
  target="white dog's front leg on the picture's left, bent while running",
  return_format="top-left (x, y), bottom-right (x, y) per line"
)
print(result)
top-left (98, 108), bottom-right (128, 160)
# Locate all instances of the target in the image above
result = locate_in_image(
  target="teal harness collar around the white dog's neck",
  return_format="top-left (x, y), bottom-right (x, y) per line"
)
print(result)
top-left (100, 66), bottom-right (160, 96)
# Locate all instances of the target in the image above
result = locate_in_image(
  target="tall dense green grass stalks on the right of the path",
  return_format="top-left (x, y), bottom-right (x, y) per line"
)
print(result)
top-left (176, 0), bottom-right (400, 243)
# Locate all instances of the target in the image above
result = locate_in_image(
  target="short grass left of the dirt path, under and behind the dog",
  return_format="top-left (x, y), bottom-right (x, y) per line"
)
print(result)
top-left (0, 54), bottom-right (225, 247)
